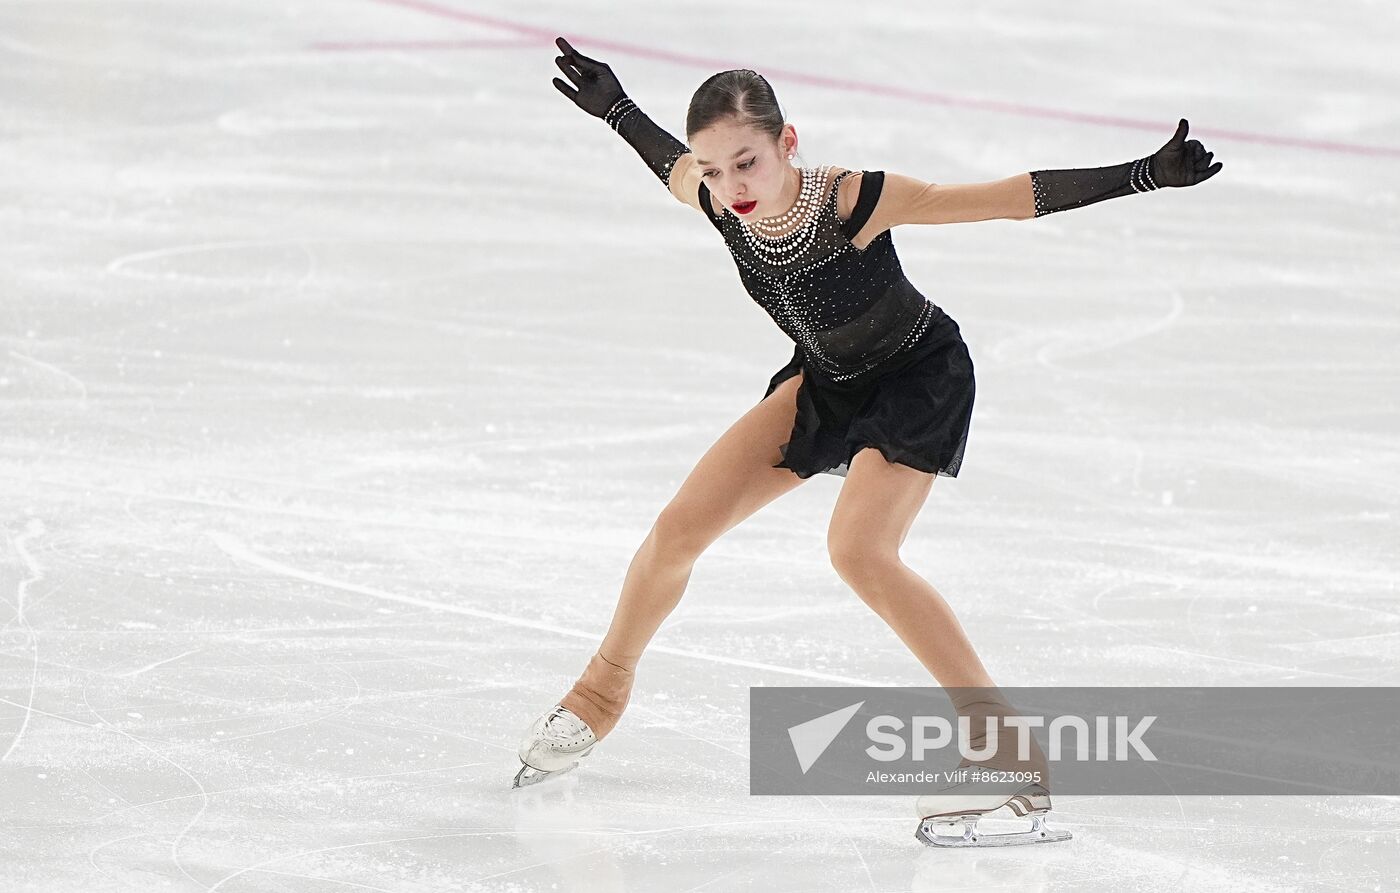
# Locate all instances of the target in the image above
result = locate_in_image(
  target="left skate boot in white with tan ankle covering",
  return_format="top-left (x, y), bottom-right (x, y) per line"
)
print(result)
top-left (511, 654), bottom-right (633, 788)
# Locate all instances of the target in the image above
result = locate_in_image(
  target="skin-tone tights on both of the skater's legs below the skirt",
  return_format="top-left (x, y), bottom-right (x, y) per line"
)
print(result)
top-left (561, 374), bottom-right (1030, 761)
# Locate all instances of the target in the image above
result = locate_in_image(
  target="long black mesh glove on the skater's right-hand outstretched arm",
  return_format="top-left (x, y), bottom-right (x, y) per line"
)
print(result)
top-left (1030, 118), bottom-right (1225, 217)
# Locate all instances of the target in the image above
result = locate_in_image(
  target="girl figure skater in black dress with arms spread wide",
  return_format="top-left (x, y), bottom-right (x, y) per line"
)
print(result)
top-left (514, 38), bottom-right (1224, 845)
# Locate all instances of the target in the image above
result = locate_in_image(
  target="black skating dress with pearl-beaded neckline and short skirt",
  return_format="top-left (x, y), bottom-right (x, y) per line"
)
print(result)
top-left (671, 158), bottom-right (976, 477)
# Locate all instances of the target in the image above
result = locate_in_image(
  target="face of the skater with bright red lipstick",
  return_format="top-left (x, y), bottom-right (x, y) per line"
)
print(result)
top-left (690, 125), bottom-right (797, 220)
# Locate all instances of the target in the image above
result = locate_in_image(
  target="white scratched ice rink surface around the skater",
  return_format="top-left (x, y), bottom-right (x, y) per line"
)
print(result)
top-left (0, 0), bottom-right (1400, 893)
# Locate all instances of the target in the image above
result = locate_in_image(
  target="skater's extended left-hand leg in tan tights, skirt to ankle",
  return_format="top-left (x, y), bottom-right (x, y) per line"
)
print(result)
top-left (561, 372), bottom-right (804, 740)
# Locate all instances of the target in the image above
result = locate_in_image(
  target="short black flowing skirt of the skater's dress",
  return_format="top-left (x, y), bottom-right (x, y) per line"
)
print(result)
top-left (763, 318), bottom-right (977, 479)
